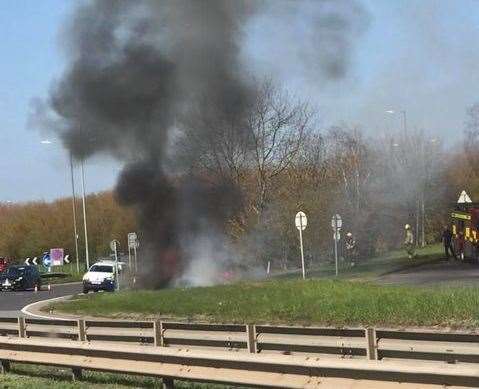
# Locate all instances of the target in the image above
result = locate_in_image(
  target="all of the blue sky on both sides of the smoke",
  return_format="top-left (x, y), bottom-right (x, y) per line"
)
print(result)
top-left (0, 0), bottom-right (479, 202)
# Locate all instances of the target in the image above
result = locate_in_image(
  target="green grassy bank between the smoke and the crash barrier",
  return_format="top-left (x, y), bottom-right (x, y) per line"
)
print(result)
top-left (49, 279), bottom-right (479, 327)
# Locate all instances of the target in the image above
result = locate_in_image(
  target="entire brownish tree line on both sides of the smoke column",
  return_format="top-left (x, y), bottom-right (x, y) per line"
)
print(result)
top-left (0, 81), bottom-right (479, 267)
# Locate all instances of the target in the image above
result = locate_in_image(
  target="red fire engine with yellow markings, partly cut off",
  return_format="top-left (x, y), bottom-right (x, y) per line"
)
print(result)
top-left (451, 203), bottom-right (479, 261)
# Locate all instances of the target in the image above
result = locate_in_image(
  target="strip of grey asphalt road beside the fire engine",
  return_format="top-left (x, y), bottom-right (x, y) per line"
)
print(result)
top-left (378, 261), bottom-right (479, 285)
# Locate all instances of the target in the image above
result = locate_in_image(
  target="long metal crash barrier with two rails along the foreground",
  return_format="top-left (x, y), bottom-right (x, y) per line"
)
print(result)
top-left (0, 318), bottom-right (479, 388)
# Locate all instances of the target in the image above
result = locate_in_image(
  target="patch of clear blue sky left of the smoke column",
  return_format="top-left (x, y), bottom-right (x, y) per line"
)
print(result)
top-left (0, 0), bottom-right (118, 202)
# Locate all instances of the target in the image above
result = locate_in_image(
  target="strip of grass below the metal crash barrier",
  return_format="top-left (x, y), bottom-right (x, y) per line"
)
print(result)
top-left (0, 364), bottom-right (219, 389)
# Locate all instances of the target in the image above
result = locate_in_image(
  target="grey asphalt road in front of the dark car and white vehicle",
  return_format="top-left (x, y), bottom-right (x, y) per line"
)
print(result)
top-left (0, 283), bottom-right (82, 317)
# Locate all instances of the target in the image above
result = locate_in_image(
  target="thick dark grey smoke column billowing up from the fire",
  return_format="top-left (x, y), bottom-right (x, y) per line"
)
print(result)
top-left (44, 0), bottom-right (368, 286)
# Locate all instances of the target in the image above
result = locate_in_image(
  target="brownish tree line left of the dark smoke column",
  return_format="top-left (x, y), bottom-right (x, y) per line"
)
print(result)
top-left (0, 192), bottom-right (136, 262)
